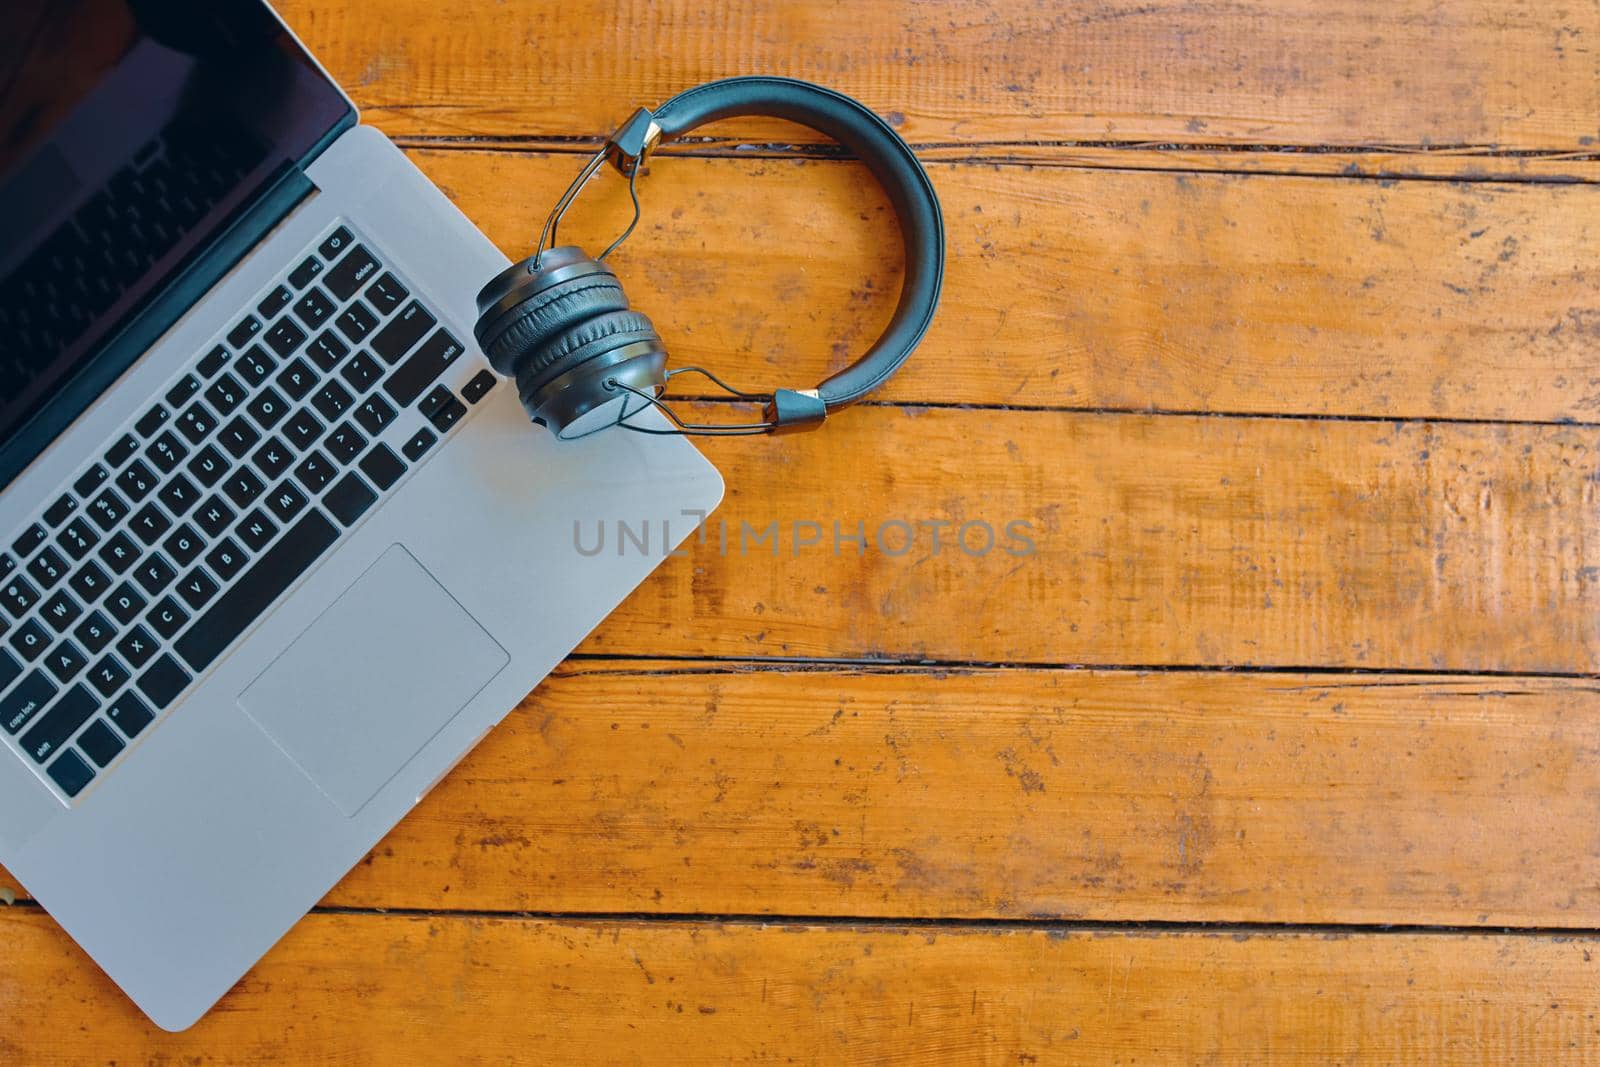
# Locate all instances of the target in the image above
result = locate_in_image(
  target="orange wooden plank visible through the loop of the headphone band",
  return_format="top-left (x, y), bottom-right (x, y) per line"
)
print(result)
top-left (403, 152), bottom-right (1600, 421)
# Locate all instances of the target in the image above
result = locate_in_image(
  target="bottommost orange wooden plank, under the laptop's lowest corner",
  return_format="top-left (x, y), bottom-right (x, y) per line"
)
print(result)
top-left (0, 912), bottom-right (1600, 1067)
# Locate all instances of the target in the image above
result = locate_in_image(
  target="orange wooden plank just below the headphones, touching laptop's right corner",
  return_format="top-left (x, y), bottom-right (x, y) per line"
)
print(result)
top-left (556, 405), bottom-right (1600, 673)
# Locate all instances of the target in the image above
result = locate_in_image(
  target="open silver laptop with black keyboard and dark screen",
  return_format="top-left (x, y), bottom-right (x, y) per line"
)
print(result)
top-left (0, 0), bottom-right (722, 1030)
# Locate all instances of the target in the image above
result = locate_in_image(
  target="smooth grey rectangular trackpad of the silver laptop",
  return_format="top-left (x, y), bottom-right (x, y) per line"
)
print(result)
top-left (238, 544), bottom-right (510, 816)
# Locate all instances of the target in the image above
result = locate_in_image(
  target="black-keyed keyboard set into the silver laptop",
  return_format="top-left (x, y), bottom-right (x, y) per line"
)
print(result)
top-left (0, 224), bottom-right (496, 798)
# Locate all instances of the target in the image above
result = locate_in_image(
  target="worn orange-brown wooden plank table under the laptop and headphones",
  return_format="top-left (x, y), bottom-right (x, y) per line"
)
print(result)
top-left (0, 0), bottom-right (1600, 1064)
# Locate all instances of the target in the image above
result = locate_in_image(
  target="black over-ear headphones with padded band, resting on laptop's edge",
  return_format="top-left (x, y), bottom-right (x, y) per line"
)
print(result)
top-left (474, 77), bottom-right (944, 440)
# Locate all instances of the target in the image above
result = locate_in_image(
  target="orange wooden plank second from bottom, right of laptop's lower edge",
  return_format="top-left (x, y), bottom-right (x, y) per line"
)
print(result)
top-left (328, 662), bottom-right (1600, 926)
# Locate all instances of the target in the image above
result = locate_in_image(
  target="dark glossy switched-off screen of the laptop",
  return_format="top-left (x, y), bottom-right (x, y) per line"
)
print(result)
top-left (0, 0), bottom-right (350, 483)
